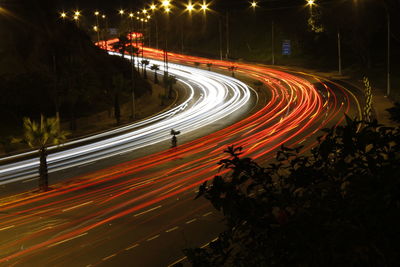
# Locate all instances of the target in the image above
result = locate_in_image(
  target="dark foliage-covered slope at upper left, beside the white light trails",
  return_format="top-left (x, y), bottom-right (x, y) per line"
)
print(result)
top-left (0, 0), bottom-right (150, 133)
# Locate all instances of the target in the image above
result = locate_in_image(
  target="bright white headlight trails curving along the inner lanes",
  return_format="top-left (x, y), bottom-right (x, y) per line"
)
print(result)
top-left (0, 56), bottom-right (250, 185)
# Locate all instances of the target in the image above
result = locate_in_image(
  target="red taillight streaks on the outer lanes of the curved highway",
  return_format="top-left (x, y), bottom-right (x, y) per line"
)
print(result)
top-left (0, 42), bottom-right (362, 262)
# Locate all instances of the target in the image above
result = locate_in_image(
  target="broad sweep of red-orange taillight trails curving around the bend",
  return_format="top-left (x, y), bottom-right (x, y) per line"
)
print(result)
top-left (0, 41), bottom-right (359, 265)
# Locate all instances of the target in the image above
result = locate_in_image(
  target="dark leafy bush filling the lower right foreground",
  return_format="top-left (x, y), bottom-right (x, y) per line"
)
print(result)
top-left (185, 119), bottom-right (400, 266)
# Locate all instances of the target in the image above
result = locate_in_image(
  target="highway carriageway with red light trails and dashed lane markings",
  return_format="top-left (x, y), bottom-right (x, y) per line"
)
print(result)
top-left (0, 45), bottom-right (360, 266)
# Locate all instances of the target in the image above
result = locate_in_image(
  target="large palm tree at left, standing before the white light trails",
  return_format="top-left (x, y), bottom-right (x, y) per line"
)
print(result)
top-left (13, 115), bottom-right (68, 191)
